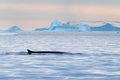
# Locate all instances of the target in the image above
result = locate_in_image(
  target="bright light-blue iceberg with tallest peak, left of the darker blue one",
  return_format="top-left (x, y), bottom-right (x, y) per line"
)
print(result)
top-left (35, 20), bottom-right (91, 32)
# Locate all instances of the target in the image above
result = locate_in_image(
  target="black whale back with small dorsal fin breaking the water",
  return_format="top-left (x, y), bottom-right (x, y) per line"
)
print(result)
top-left (27, 49), bottom-right (67, 55)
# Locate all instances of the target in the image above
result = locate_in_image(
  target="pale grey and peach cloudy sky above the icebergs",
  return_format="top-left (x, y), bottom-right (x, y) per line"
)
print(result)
top-left (0, 0), bottom-right (120, 30)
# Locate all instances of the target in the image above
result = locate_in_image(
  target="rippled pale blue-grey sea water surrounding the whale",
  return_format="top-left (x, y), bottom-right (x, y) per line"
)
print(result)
top-left (0, 32), bottom-right (120, 80)
